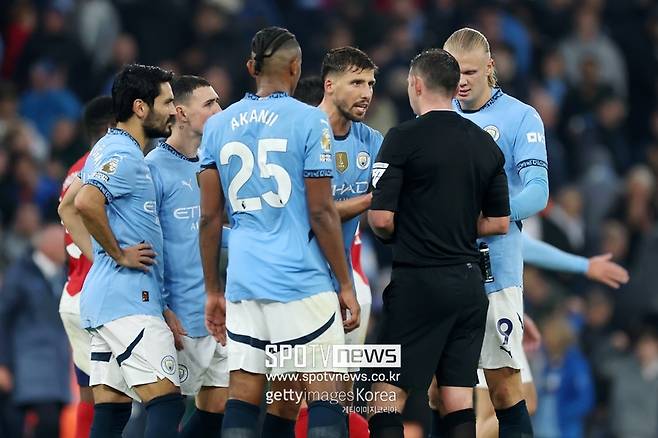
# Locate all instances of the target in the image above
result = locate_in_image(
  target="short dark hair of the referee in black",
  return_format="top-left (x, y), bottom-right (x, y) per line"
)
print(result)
top-left (411, 49), bottom-right (460, 94)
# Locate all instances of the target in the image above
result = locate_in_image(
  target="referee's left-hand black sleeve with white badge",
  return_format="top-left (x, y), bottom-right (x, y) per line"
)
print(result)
top-left (370, 128), bottom-right (408, 212)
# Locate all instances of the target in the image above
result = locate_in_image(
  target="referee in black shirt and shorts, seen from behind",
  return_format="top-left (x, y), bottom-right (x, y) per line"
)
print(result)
top-left (368, 49), bottom-right (510, 438)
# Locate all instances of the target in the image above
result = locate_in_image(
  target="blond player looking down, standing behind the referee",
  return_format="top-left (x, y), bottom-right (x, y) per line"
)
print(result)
top-left (430, 28), bottom-right (548, 438)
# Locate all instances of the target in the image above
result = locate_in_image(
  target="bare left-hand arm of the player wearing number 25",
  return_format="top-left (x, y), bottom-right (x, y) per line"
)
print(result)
top-left (199, 168), bottom-right (226, 345)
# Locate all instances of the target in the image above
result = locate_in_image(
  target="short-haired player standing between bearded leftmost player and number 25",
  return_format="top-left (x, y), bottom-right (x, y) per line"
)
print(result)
top-left (146, 76), bottom-right (228, 437)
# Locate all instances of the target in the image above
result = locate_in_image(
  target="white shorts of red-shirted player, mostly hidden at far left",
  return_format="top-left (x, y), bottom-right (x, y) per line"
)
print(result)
top-left (59, 288), bottom-right (91, 375)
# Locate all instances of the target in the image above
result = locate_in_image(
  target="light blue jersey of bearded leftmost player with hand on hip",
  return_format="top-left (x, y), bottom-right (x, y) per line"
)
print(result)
top-left (80, 129), bottom-right (164, 328)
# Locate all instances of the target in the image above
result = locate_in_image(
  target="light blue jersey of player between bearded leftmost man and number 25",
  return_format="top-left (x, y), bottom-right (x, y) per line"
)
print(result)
top-left (146, 143), bottom-right (208, 337)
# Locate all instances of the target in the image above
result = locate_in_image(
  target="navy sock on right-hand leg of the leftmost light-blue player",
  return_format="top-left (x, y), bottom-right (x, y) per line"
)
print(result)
top-left (144, 394), bottom-right (185, 438)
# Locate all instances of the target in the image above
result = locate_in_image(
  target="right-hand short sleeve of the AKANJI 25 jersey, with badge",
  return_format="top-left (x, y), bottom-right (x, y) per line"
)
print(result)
top-left (304, 109), bottom-right (334, 178)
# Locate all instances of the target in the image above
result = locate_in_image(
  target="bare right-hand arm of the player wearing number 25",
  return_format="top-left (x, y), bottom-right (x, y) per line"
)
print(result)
top-left (304, 177), bottom-right (361, 331)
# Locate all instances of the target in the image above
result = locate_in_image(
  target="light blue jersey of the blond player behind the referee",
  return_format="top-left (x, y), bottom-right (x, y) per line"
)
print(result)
top-left (454, 88), bottom-right (548, 293)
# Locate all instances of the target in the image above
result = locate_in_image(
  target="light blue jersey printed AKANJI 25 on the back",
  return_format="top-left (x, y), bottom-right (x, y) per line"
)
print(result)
top-left (199, 92), bottom-right (334, 302)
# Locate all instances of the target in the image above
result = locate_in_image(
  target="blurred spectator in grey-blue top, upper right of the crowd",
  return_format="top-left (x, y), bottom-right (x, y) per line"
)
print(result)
top-left (560, 5), bottom-right (628, 96)
